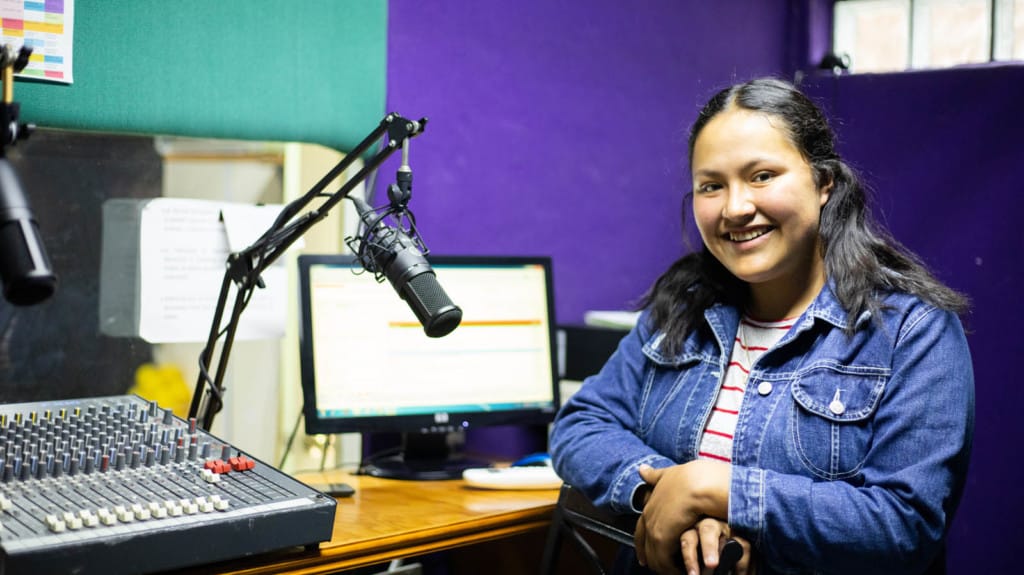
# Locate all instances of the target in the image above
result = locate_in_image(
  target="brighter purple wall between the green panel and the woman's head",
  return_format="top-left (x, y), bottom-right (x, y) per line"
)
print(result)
top-left (378, 0), bottom-right (788, 322)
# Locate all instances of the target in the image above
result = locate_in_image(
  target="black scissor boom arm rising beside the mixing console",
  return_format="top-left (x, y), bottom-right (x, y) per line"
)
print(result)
top-left (188, 113), bottom-right (427, 431)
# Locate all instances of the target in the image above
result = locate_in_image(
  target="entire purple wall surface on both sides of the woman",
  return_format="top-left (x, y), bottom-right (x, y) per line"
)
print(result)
top-left (379, 0), bottom-right (1024, 574)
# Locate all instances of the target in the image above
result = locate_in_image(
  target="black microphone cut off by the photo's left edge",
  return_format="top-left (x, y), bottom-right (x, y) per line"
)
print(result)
top-left (0, 158), bottom-right (57, 306)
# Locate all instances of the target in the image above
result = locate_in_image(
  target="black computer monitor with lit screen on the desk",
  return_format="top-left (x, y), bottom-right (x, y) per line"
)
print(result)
top-left (298, 255), bottom-right (559, 479)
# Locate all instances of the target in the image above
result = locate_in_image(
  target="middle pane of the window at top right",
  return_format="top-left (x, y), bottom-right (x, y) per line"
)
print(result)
top-left (912, 0), bottom-right (991, 68)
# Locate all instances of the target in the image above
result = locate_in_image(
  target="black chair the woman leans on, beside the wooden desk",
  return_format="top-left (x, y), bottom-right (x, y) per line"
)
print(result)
top-left (541, 485), bottom-right (743, 575)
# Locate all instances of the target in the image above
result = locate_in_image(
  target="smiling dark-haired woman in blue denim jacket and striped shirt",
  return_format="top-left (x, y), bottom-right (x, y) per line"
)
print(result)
top-left (551, 79), bottom-right (974, 575)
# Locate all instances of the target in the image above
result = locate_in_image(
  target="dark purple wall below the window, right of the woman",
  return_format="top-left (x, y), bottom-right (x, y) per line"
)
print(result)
top-left (808, 65), bottom-right (1024, 574)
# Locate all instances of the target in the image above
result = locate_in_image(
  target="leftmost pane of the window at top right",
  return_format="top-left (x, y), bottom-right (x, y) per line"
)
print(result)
top-left (834, 0), bottom-right (910, 72)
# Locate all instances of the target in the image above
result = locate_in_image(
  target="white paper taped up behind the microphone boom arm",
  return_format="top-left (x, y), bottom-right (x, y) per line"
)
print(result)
top-left (99, 197), bottom-right (299, 343)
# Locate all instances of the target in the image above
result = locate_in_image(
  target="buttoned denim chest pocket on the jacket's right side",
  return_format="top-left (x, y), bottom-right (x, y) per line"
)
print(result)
top-left (791, 363), bottom-right (889, 481)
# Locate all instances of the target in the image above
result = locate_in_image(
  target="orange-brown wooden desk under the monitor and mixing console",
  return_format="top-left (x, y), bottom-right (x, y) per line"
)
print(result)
top-left (177, 472), bottom-right (558, 575)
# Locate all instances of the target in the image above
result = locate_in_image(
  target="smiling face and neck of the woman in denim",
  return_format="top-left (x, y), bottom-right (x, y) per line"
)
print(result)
top-left (692, 104), bottom-right (831, 318)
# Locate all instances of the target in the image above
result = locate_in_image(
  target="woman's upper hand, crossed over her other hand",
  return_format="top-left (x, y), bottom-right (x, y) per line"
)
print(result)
top-left (633, 459), bottom-right (731, 574)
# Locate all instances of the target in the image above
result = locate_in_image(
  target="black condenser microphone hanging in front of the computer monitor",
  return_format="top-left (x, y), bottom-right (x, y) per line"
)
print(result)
top-left (349, 196), bottom-right (462, 338)
